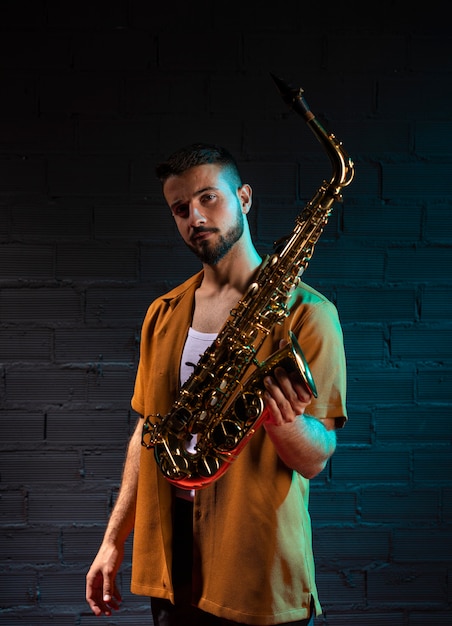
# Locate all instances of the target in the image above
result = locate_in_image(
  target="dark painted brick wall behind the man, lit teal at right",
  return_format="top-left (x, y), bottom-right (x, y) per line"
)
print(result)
top-left (0, 0), bottom-right (452, 626)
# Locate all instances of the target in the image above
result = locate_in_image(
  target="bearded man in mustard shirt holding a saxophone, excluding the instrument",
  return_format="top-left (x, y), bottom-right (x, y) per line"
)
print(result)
top-left (86, 144), bottom-right (346, 626)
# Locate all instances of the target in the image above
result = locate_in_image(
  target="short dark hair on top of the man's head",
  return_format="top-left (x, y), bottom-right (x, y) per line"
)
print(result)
top-left (155, 143), bottom-right (242, 187)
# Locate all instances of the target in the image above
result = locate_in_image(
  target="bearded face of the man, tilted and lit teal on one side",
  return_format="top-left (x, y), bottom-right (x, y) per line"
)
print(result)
top-left (163, 164), bottom-right (251, 265)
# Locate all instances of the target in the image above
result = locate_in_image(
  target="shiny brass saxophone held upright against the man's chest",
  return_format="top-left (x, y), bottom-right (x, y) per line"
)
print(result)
top-left (141, 75), bottom-right (354, 489)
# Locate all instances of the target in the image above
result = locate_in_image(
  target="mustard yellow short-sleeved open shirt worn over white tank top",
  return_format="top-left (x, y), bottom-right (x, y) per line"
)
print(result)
top-left (131, 272), bottom-right (346, 625)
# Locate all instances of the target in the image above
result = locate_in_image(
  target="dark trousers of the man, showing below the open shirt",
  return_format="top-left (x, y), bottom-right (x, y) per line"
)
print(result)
top-left (151, 498), bottom-right (314, 626)
